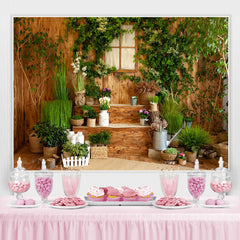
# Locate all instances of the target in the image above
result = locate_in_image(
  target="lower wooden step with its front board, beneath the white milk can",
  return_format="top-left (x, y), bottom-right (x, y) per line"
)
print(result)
top-left (72, 124), bottom-right (152, 158)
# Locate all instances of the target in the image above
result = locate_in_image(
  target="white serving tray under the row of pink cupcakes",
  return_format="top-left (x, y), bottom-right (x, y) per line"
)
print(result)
top-left (84, 196), bottom-right (156, 206)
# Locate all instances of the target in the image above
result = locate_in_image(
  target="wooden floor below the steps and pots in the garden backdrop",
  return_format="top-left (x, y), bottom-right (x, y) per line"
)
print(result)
top-left (14, 146), bottom-right (227, 170)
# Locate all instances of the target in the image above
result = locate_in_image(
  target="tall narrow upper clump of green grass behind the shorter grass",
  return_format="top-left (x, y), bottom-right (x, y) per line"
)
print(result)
top-left (53, 62), bottom-right (69, 100)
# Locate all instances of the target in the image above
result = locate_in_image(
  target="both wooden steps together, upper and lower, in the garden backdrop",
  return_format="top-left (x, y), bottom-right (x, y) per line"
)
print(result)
top-left (72, 104), bottom-right (151, 159)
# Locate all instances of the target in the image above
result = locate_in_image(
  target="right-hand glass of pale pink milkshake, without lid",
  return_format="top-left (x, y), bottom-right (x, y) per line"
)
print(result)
top-left (160, 172), bottom-right (178, 198)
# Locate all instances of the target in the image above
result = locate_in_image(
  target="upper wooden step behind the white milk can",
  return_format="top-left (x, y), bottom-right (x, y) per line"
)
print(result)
top-left (73, 104), bottom-right (150, 123)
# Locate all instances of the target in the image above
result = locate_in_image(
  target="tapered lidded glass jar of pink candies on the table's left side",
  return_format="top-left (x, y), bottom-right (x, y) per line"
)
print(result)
top-left (35, 159), bottom-right (53, 203)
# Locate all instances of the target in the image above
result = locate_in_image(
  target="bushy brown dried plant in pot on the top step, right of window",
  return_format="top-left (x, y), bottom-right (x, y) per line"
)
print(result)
top-left (135, 80), bottom-right (161, 105)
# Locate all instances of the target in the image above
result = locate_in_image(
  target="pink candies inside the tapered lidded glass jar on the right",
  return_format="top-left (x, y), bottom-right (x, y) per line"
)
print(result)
top-left (188, 177), bottom-right (205, 199)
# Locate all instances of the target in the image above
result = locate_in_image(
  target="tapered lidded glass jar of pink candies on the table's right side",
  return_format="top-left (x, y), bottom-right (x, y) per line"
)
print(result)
top-left (187, 159), bottom-right (206, 204)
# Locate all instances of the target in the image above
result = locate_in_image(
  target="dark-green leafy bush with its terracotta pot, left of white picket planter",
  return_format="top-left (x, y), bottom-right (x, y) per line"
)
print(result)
top-left (36, 123), bottom-right (67, 159)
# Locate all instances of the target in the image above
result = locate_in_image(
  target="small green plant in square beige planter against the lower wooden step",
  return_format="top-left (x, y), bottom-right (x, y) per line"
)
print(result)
top-left (89, 130), bottom-right (111, 158)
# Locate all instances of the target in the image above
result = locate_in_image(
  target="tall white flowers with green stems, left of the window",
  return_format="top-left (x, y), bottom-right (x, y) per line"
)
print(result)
top-left (71, 52), bottom-right (87, 92)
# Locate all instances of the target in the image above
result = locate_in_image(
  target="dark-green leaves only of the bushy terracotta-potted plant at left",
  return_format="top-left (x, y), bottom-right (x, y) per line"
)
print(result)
top-left (35, 122), bottom-right (67, 147)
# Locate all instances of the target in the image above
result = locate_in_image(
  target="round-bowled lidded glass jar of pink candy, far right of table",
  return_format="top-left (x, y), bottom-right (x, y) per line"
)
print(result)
top-left (211, 157), bottom-right (232, 199)
